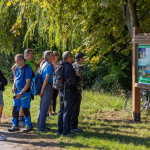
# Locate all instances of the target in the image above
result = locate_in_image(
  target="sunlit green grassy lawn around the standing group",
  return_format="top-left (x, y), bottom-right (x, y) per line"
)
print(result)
top-left (4, 85), bottom-right (150, 150)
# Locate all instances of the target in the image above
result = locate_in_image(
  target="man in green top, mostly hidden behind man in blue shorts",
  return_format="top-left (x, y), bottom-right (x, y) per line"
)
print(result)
top-left (11, 48), bottom-right (36, 126)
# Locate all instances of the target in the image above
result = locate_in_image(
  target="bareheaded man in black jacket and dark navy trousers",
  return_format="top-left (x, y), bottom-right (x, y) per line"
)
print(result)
top-left (57, 51), bottom-right (76, 136)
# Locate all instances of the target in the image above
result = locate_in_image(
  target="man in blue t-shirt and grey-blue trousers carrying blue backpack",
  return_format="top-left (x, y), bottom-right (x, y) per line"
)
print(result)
top-left (37, 50), bottom-right (54, 131)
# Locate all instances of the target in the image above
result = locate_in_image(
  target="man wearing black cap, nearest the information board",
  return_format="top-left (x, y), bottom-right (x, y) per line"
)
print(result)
top-left (70, 53), bottom-right (85, 132)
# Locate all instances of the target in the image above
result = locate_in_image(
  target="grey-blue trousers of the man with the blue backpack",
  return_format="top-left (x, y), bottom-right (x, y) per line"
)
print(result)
top-left (37, 84), bottom-right (52, 131)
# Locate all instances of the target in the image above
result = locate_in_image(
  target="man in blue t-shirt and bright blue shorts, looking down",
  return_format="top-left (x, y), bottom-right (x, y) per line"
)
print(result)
top-left (8, 54), bottom-right (32, 132)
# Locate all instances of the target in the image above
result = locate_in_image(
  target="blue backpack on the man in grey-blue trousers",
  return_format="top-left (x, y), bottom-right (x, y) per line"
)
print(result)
top-left (30, 64), bottom-right (49, 95)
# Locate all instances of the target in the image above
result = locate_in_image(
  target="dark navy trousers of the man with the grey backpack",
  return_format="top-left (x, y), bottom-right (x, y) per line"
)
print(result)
top-left (57, 90), bottom-right (75, 135)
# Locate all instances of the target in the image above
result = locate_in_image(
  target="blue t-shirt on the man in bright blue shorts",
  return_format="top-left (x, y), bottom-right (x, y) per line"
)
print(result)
top-left (14, 65), bottom-right (32, 88)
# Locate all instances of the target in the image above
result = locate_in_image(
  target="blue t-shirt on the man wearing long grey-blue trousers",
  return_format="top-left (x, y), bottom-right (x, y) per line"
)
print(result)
top-left (42, 61), bottom-right (53, 83)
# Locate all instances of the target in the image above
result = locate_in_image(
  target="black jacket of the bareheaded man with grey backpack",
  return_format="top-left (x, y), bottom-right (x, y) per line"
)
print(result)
top-left (60, 61), bottom-right (76, 90)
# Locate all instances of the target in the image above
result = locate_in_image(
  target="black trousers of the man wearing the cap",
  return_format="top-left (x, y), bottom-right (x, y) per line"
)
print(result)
top-left (70, 92), bottom-right (82, 129)
